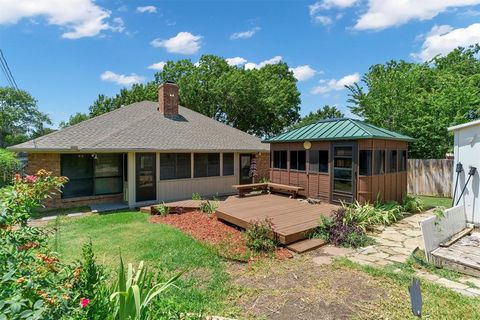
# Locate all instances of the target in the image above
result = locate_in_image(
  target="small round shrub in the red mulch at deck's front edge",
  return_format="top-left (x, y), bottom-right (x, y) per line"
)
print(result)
top-left (245, 218), bottom-right (278, 253)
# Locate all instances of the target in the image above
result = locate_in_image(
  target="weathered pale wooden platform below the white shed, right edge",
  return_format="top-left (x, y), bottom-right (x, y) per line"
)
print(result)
top-left (431, 232), bottom-right (480, 277)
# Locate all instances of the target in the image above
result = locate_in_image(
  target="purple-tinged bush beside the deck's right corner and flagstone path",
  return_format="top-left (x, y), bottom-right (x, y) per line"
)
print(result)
top-left (312, 208), bottom-right (375, 248)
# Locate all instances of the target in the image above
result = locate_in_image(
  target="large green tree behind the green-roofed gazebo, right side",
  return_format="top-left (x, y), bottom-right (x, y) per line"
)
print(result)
top-left (349, 46), bottom-right (480, 158)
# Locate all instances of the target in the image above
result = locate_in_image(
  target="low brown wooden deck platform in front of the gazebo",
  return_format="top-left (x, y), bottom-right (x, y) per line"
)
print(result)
top-left (216, 194), bottom-right (338, 244)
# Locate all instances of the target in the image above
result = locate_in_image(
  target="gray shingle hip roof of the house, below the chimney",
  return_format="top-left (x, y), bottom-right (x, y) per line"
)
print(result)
top-left (9, 101), bottom-right (269, 152)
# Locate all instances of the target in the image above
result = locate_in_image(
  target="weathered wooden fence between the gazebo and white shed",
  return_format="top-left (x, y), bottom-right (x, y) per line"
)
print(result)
top-left (407, 159), bottom-right (453, 197)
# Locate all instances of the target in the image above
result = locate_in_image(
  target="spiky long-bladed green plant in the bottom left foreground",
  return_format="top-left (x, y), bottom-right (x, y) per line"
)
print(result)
top-left (110, 256), bottom-right (182, 320)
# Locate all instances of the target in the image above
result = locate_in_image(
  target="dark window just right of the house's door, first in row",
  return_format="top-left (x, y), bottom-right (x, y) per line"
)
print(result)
top-left (160, 153), bottom-right (192, 180)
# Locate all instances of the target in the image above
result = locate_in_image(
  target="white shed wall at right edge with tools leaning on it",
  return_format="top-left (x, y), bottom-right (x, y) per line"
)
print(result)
top-left (452, 124), bottom-right (480, 225)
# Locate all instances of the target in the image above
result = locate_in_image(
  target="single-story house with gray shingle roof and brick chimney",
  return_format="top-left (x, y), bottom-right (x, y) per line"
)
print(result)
top-left (10, 82), bottom-right (270, 207)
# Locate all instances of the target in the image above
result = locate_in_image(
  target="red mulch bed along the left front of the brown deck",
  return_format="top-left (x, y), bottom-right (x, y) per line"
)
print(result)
top-left (150, 211), bottom-right (292, 260)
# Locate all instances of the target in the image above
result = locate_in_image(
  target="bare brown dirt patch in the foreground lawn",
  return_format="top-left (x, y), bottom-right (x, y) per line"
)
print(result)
top-left (229, 254), bottom-right (386, 320)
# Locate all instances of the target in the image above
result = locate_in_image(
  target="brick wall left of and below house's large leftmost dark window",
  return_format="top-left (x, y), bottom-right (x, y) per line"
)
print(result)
top-left (26, 153), bottom-right (123, 209)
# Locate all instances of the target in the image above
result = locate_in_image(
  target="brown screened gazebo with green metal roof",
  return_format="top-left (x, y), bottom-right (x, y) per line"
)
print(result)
top-left (265, 118), bottom-right (413, 203)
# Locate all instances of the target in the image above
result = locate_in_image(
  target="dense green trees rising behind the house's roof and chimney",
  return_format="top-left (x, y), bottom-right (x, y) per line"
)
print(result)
top-left (90, 55), bottom-right (300, 137)
